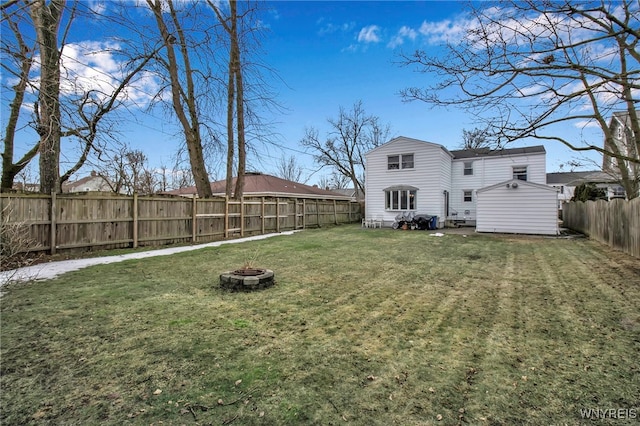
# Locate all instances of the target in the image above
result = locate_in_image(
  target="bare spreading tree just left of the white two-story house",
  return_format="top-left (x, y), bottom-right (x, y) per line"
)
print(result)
top-left (301, 101), bottom-right (391, 194)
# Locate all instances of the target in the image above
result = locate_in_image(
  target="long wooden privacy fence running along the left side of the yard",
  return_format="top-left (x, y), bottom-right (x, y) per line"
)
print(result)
top-left (0, 194), bottom-right (361, 254)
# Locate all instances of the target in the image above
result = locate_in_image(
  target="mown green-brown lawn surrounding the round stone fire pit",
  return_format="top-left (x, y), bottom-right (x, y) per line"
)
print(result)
top-left (0, 226), bottom-right (640, 425)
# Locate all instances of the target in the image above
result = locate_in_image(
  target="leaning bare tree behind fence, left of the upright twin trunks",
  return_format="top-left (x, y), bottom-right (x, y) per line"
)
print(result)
top-left (146, 0), bottom-right (212, 198)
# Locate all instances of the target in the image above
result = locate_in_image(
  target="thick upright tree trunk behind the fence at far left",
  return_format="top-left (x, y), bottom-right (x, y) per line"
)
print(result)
top-left (30, 0), bottom-right (66, 194)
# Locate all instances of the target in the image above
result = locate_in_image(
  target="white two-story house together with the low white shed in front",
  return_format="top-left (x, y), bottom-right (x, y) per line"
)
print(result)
top-left (365, 137), bottom-right (557, 233)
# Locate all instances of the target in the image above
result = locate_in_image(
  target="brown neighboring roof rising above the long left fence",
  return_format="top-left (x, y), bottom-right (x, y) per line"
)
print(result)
top-left (165, 172), bottom-right (350, 200)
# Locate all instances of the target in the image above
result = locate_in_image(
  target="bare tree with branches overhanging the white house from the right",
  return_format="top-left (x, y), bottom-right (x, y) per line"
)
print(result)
top-left (402, 0), bottom-right (640, 198)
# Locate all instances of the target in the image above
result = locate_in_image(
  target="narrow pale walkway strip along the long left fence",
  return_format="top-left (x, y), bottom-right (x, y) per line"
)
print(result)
top-left (0, 231), bottom-right (298, 287)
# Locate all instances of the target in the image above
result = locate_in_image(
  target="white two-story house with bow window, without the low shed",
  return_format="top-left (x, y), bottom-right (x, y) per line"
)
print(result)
top-left (365, 137), bottom-right (556, 233)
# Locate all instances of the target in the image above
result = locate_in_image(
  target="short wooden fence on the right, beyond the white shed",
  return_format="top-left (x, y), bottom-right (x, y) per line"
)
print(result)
top-left (562, 198), bottom-right (640, 257)
